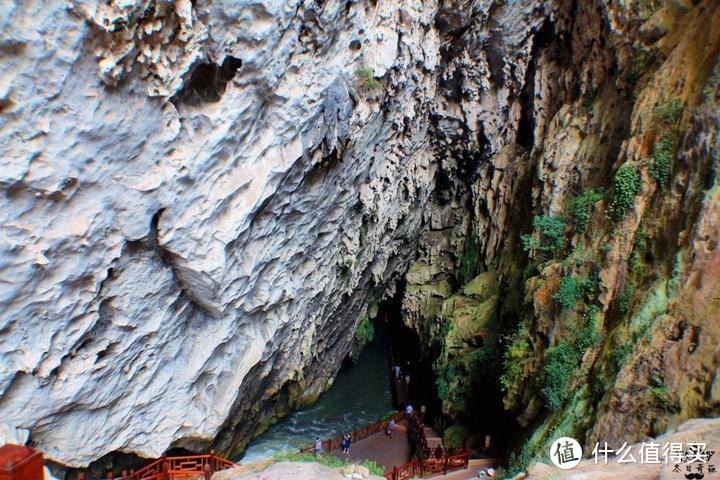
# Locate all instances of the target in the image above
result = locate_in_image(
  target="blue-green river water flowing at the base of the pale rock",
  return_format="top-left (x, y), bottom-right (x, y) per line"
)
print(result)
top-left (236, 330), bottom-right (392, 463)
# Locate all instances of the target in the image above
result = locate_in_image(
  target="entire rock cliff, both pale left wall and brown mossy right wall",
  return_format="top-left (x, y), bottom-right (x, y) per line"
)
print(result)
top-left (0, 0), bottom-right (720, 472)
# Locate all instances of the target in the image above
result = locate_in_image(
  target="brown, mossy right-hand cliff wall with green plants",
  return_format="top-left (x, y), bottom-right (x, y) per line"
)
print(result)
top-left (404, 2), bottom-right (720, 468)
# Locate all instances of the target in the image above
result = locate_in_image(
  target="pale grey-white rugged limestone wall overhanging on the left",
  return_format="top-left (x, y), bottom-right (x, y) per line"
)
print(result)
top-left (0, 0), bottom-right (439, 466)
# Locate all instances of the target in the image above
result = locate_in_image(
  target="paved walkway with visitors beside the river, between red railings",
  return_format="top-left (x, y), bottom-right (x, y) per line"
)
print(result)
top-left (332, 421), bottom-right (410, 471)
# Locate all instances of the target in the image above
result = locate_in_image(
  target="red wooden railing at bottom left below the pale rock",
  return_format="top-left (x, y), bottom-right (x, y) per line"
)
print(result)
top-left (79, 453), bottom-right (237, 480)
